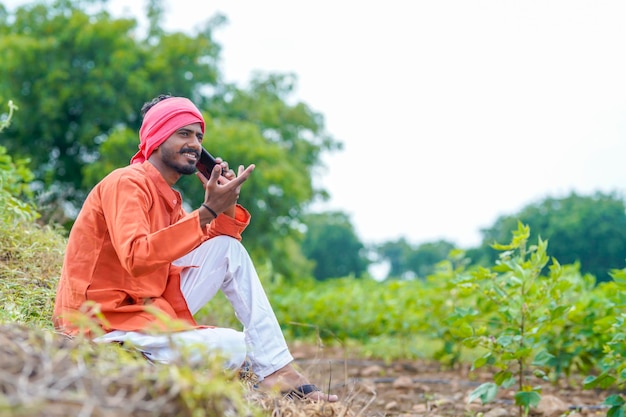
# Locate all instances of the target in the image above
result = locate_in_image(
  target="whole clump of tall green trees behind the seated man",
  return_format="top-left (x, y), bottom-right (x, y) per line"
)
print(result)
top-left (0, 0), bottom-right (340, 277)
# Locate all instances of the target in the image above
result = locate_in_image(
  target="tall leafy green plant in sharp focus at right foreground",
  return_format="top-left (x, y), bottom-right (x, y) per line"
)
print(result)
top-left (456, 223), bottom-right (568, 415)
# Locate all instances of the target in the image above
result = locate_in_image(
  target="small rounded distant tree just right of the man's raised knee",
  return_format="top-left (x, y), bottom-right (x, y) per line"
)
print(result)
top-left (302, 212), bottom-right (369, 280)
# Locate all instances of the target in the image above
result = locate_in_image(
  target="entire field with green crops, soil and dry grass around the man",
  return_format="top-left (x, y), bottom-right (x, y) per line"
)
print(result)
top-left (0, 218), bottom-right (626, 417)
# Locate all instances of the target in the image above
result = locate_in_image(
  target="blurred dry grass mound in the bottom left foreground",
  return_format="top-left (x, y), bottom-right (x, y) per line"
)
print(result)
top-left (0, 324), bottom-right (366, 417)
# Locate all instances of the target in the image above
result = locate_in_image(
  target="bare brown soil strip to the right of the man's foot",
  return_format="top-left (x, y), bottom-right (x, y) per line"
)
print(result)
top-left (292, 345), bottom-right (611, 417)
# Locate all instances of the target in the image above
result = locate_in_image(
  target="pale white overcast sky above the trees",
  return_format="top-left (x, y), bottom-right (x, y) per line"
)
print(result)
top-left (3, 0), bottom-right (626, 248)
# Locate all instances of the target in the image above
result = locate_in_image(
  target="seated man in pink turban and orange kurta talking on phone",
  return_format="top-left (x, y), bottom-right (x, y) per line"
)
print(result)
top-left (54, 95), bottom-right (337, 401)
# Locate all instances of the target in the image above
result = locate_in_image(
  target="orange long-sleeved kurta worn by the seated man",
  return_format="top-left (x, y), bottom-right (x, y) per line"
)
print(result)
top-left (53, 162), bottom-right (250, 334)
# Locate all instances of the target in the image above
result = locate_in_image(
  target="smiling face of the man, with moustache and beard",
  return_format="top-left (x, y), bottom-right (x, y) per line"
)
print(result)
top-left (159, 123), bottom-right (203, 175)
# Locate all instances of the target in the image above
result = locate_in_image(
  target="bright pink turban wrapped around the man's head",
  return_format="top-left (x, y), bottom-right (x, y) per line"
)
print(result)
top-left (130, 97), bottom-right (204, 164)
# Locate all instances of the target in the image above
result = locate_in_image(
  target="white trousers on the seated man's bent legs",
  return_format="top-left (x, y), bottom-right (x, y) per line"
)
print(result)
top-left (95, 236), bottom-right (293, 380)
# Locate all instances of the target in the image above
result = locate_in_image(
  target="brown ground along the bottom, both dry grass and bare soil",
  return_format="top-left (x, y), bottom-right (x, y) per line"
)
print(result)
top-left (0, 325), bottom-right (608, 417)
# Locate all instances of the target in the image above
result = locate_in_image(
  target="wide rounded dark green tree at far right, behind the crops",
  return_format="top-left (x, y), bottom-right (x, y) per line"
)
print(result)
top-left (468, 192), bottom-right (626, 281)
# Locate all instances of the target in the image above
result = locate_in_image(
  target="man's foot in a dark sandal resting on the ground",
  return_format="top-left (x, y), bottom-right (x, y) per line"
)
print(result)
top-left (259, 364), bottom-right (339, 402)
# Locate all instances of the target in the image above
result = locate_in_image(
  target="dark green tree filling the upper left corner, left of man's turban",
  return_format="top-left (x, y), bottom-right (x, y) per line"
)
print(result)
top-left (0, 0), bottom-right (219, 203)
